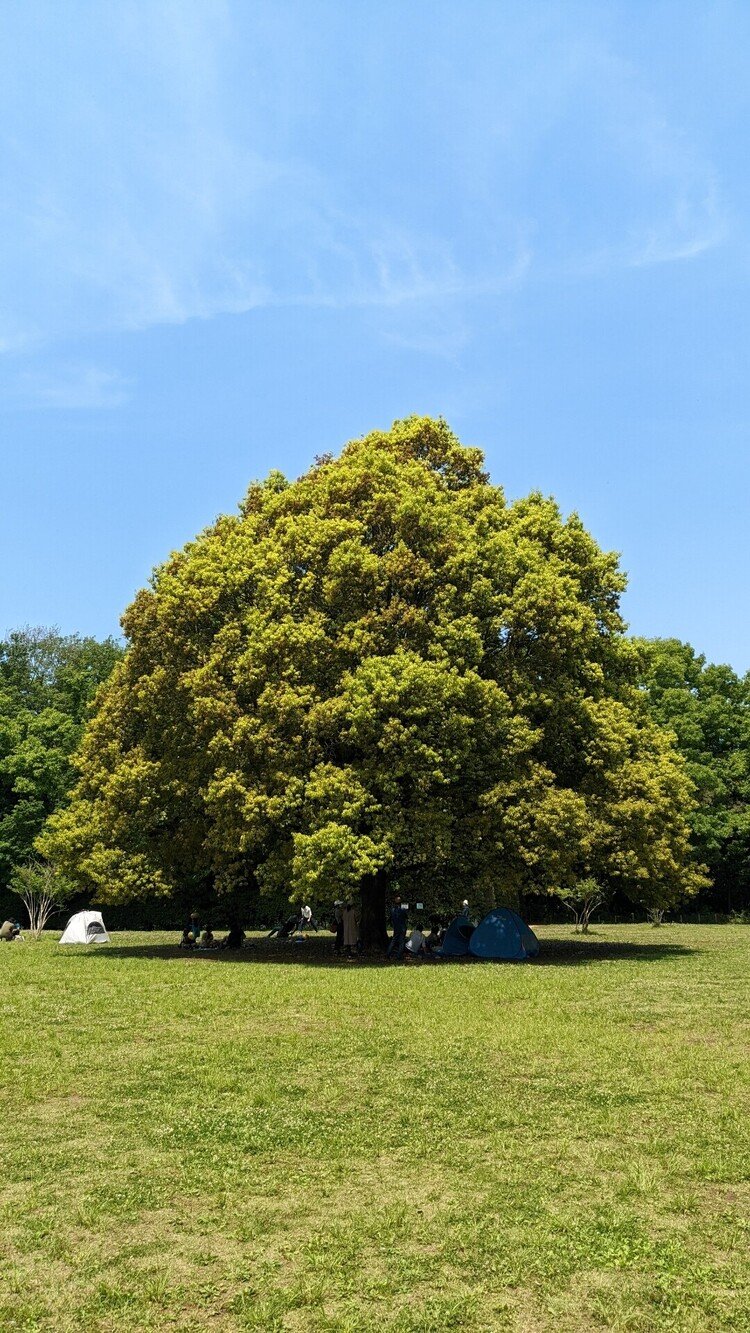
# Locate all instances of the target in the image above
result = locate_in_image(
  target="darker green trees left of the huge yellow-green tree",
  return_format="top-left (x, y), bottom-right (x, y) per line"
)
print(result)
top-left (0, 628), bottom-right (123, 885)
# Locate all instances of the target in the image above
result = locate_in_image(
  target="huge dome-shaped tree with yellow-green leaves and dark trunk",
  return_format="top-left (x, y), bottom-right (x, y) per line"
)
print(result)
top-left (41, 419), bottom-right (695, 942)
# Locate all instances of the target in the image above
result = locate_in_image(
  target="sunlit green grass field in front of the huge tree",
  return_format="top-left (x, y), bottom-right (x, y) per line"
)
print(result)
top-left (0, 925), bottom-right (750, 1333)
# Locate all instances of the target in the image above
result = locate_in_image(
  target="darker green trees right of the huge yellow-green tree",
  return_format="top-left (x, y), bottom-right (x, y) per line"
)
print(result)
top-left (638, 639), bottom-right (750, 912)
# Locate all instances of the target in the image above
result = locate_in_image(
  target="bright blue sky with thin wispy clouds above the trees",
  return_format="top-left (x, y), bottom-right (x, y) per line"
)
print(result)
top-left (0, 0), bottom-right (750, 670)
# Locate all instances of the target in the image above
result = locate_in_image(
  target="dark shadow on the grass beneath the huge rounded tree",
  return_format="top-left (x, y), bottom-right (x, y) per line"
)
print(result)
top-left (64, 936), bottom-right (698, 969)
